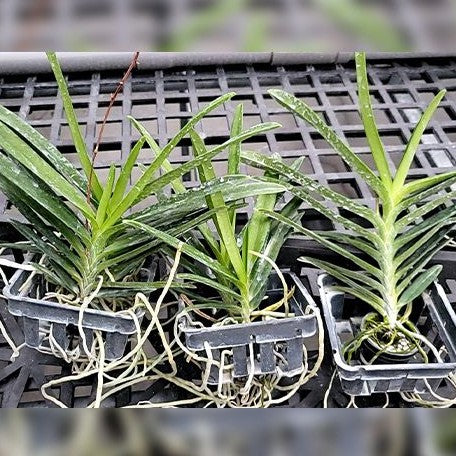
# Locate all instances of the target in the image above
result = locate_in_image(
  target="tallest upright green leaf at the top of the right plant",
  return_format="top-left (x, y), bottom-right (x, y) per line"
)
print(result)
top-left (355, 52), bottom-right (392, 188)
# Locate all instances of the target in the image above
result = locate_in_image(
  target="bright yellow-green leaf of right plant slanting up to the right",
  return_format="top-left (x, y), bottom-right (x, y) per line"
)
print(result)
top-left (393, 90), bottom-right (446, 192)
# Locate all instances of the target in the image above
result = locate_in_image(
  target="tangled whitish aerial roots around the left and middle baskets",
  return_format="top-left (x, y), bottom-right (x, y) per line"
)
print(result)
top-left (35, 244), bottom-right (324, 408)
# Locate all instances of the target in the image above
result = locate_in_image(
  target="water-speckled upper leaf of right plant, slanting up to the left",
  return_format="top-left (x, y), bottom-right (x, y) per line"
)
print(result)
top-left (268, 89), bottom-right (386, 197)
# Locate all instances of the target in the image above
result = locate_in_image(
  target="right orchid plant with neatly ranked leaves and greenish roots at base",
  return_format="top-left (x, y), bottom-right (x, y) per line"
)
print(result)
top-left (242, 53), bottom-right (456, 359)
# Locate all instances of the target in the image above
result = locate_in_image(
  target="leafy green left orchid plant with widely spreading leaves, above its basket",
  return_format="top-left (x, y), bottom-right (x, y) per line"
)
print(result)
top-left (0, 53), bottom-right (277, 310)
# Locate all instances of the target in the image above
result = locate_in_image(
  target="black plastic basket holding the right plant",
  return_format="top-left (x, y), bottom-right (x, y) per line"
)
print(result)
top-left (318, 274), bottom-right (456, 396)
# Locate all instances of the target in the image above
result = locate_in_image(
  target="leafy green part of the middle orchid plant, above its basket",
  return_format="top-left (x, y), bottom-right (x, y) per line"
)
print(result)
top-left (126, 105), bottom-right (302, 322)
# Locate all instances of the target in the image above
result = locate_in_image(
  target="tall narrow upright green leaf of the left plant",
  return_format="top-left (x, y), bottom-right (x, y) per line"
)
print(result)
top-left (47, 52), bottom-right (103, 199)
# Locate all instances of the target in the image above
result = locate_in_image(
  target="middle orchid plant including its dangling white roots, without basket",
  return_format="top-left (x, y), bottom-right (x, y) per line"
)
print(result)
top-left (124, 105), bottom-right (324, 407)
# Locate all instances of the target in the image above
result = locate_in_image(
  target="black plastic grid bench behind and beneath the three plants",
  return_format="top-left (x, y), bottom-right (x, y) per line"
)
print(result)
top-left (0, 53), bottom-right (456, 405)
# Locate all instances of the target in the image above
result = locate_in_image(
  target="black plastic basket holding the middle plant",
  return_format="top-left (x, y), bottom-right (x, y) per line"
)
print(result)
top-left (179, 271), bottom-right (317, 384)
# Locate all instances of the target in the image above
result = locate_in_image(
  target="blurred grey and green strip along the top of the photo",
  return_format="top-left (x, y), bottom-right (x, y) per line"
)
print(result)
top-left (0, 0), bottom-right (456, 52)
